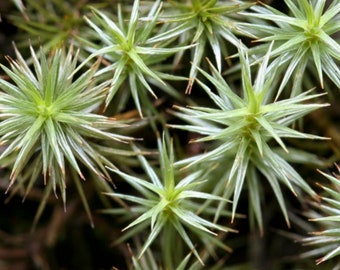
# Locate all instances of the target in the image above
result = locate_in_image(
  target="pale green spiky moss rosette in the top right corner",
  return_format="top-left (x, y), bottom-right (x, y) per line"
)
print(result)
top-left (238, 0), bottom-right (340, 96)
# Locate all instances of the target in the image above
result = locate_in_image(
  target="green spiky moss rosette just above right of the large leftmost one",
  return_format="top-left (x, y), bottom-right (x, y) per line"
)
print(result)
top-left (75, 0), bottom-right (190, 116)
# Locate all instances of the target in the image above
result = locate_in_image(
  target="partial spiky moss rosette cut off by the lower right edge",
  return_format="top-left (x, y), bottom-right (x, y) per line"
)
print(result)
top-left (301, 163), bottom-right (340, 269)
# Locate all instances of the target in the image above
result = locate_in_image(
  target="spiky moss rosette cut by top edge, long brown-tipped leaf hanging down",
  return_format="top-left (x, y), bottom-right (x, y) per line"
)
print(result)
top-left (161, 0), bottom-right (254, 93)
